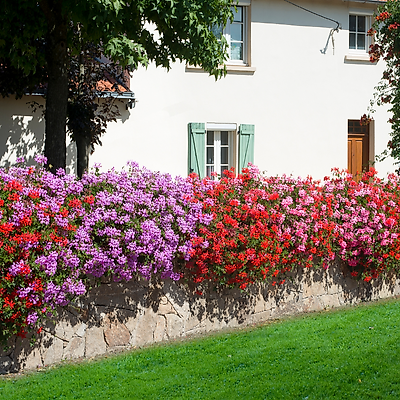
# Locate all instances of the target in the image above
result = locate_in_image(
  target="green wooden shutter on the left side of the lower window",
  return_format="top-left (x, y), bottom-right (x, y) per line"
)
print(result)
top-left (188, 122), bottom-right (206, 178)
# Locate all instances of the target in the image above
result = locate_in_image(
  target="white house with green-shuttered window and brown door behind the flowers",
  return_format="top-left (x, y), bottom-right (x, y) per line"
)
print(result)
top-left (0, 0), bottom-right (394, 178)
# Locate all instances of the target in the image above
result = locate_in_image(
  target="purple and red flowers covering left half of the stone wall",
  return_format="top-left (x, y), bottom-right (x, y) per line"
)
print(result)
top-left (0, 157), bottom-right (206, 341)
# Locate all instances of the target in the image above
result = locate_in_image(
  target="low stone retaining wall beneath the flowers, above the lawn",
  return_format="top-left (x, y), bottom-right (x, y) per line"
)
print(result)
top-left (0, 263), bottom-right (400, 373)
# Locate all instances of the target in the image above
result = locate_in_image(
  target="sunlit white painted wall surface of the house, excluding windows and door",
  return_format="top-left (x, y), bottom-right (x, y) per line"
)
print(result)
top-left (0, 0), bottom-right (394, 179)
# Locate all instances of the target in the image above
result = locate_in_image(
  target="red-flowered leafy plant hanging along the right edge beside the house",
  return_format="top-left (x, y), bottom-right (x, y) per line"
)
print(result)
top-left (368, 0), bottom-right (400, 169)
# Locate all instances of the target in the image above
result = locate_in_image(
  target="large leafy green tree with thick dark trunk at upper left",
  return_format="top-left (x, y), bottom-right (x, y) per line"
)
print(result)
top-left (0, 0), bottom-right (232, 169)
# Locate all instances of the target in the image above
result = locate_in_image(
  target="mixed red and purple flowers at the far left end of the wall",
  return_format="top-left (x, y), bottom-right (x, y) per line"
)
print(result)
top-left (0, 157), bottom-right (85, 340)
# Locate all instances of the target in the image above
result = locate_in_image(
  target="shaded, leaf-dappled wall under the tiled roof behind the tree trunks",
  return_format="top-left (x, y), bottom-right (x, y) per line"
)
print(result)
top-left (0, 96), bottom-right (76, 173)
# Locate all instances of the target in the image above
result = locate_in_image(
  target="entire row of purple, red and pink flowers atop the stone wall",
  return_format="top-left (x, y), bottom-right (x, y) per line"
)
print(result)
top-left (0, 157), bottom-right (400, 341)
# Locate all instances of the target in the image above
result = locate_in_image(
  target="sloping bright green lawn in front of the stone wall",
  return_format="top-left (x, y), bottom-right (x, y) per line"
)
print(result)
top-left (0, 300), bottom-right (400, 400)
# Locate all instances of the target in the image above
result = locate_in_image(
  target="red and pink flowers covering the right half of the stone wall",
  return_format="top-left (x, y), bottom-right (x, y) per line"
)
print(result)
top-left (186, 166), bottom-right (400, 289)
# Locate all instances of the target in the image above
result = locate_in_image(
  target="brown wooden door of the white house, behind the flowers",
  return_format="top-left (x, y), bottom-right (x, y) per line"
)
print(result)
top-left (347, 120), bottom-right (369, 179)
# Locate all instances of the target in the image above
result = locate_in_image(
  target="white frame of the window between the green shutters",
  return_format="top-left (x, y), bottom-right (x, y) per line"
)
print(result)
top-left (205, 123), bottom-right (238, 179)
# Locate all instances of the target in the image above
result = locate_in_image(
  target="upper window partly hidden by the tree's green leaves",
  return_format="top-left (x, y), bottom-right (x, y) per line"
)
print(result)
top-left (213, 6), bottom-right (249, 64)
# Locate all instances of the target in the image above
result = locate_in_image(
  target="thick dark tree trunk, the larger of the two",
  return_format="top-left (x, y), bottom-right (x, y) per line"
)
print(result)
top-left (40, 0), bottom-right (68, 172)
